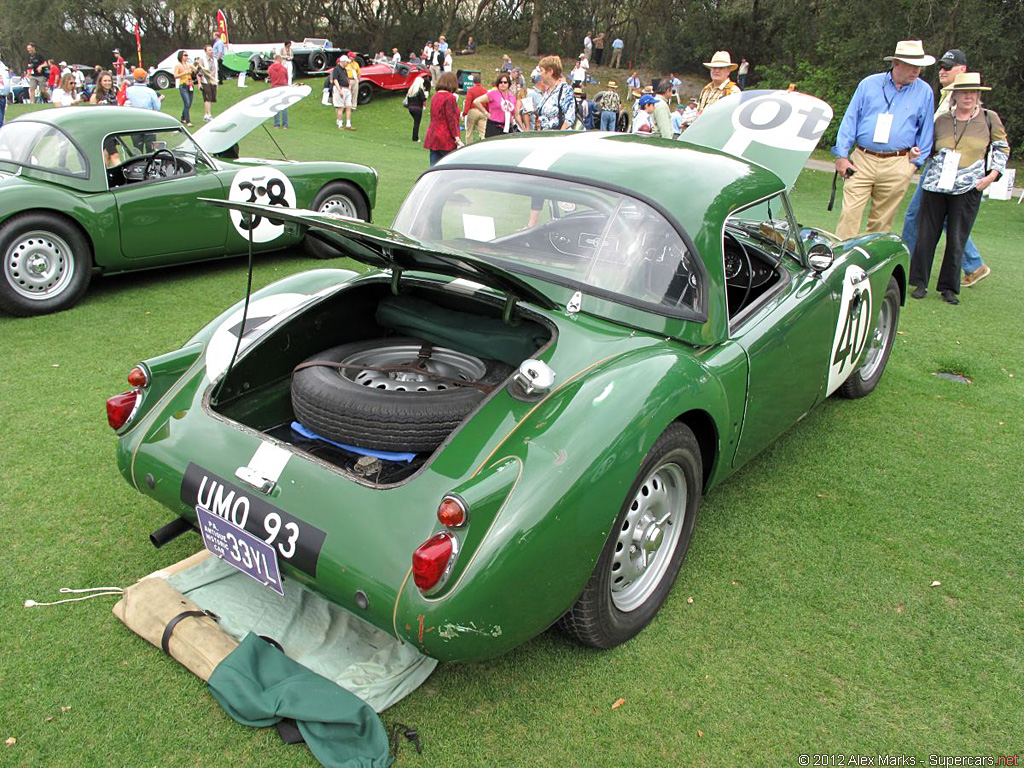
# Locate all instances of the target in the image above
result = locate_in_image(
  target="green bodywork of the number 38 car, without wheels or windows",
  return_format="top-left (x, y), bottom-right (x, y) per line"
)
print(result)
top-left (0, 102), bottom-right (377, 313)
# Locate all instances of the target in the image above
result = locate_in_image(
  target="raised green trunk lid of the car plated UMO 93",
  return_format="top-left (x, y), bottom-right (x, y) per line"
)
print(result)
top-left (202, 198), bottom-right (557, 309)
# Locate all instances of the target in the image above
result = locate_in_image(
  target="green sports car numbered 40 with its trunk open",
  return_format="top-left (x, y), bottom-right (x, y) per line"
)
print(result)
top-left (108, 91), bottom-right (908, 660)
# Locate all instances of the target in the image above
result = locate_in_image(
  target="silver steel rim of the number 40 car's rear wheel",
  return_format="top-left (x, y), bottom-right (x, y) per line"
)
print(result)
top-left (610, 462), bottom-right (688, 613)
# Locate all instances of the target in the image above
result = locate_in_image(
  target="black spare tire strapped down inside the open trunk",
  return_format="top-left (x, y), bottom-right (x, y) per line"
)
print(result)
top-left (292, 338), bottom-right (513, 453)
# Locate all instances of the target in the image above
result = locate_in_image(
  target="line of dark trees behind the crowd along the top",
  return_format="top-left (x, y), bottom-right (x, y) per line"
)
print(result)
top-left (0, 0), bottom-right (1024, 146)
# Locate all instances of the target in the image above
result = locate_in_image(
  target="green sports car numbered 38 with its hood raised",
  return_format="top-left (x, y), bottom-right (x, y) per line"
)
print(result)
top-left (0, 85), bottom-right (377, 315)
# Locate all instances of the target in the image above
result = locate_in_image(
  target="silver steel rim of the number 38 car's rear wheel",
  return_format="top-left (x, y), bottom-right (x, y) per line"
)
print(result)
top-left (3, 230), bottom-right (75, 301)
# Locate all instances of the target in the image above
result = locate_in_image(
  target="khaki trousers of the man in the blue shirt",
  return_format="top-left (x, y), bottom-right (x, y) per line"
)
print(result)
top-left (836, 146), bottom-right (914, 240)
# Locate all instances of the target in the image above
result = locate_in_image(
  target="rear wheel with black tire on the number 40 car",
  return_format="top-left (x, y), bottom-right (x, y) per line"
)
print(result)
top-left (558, 424), bottom-right (703, 648)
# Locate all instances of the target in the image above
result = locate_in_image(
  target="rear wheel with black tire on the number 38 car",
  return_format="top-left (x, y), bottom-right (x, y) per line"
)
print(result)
top-left (0, 213), bottom-right (92, 317)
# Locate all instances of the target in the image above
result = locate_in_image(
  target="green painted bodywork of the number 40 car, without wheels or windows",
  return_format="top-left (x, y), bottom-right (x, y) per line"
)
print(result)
top-left (118, 93), bottom-right (908, 662)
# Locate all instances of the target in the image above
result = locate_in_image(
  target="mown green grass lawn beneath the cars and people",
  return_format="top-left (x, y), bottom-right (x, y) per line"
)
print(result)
top-left (0, 75), bottom-right (1024, 768)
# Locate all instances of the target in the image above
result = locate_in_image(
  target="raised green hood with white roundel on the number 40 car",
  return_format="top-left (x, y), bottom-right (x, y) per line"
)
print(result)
top-left (682, 91), bottom-right (833, 191)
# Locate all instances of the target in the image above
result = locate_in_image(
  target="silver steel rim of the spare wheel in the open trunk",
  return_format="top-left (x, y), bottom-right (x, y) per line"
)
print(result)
top-left (339, 344), bottom-right (487, 392)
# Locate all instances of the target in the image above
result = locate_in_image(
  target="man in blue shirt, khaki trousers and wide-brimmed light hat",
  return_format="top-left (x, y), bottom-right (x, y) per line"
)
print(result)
top-left (833, 40), bottom-right (935, 240)
